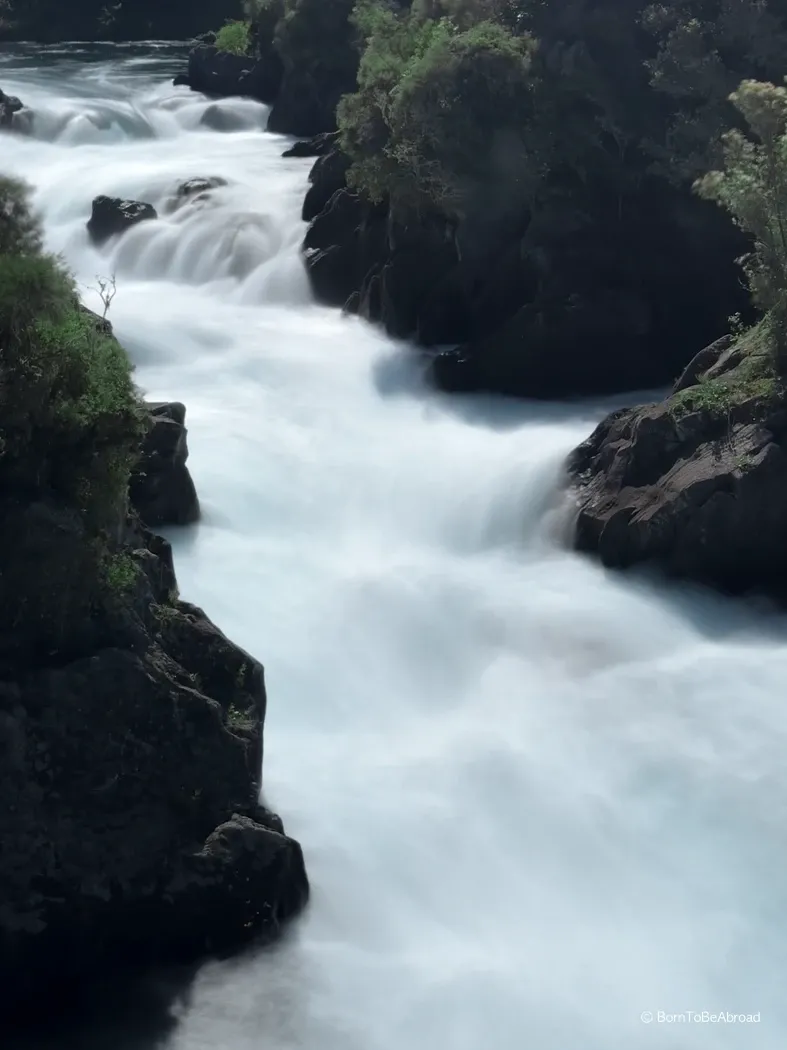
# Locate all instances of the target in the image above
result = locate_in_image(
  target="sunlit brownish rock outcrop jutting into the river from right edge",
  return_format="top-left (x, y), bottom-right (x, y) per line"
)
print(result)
top-left (569, 326), bottom-right (787, 597)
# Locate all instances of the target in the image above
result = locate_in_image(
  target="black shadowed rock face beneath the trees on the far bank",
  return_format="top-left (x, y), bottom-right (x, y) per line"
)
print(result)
top-left (302, 148), bottom-right (745, 398)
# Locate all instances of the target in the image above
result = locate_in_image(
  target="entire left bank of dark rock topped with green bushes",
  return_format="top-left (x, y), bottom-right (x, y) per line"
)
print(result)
top-left (0, 180), bottom-right (309, 1023)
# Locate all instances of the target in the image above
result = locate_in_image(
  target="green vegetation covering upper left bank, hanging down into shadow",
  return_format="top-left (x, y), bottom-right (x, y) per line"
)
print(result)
top-left (0, 179), bottom-right (146, 658)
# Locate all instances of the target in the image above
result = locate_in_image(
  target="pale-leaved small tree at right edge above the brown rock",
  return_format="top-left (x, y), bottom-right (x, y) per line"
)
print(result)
top-left (696, 80), bottom-right (787, 358)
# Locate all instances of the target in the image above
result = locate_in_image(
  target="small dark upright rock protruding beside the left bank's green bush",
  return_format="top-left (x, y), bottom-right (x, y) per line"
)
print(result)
top-left (129, 402), bottom-right (199, 527)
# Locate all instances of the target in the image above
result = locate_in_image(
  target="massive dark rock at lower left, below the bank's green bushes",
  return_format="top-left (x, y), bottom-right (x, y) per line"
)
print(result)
top-left (0, 512), bottom-right (309, 1020)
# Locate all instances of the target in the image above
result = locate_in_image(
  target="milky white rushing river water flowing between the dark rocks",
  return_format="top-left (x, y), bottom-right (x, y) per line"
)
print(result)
top-left (0, 45), bottom-right (787, 1050)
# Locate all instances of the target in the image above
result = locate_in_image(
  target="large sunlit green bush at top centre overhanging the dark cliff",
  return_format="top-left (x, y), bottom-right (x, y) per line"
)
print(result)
top-left (338, 0), bottom-right (543, 213)
